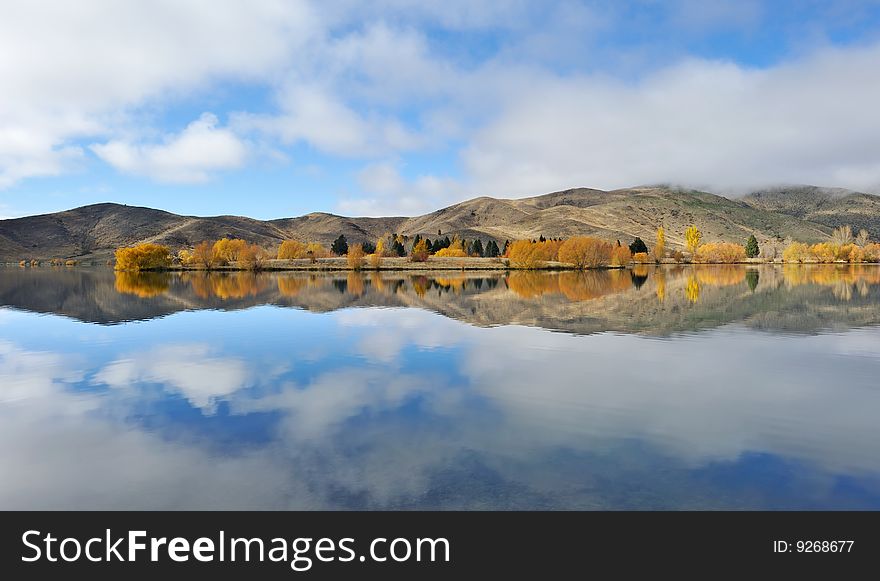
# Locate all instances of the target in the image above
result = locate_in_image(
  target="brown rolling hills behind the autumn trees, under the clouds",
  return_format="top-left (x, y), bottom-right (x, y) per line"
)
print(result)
top-left (0, 186), bottom-right (880, 262)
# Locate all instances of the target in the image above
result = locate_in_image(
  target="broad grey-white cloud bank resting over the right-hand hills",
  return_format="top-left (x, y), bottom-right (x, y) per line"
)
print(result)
top-left (463, 45), bottom-right (880, 195)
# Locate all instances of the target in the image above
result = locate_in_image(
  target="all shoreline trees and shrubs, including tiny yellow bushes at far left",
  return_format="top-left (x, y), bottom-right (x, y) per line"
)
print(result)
top-left (20, 226), bottom-right (880, 271)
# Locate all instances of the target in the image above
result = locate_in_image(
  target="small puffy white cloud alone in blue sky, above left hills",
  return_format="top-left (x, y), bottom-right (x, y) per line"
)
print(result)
top-left (91, 113), bottom-right (247, 183)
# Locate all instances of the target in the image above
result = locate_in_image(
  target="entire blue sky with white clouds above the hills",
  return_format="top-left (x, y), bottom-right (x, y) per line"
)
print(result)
top-left (0, 0), bottom-right (880, 218)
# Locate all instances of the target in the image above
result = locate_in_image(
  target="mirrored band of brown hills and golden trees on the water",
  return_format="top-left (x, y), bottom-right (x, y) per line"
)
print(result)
top-left (0, 265), bottom-right (880, 335)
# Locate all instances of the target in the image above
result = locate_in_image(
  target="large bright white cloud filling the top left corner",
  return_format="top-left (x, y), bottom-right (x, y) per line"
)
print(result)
top-left (0, 0), bottom-right (316, 187)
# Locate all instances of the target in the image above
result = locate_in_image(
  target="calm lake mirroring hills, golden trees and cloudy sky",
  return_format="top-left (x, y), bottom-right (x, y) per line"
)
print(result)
top-left (0, 265), bottom-right (880, 510)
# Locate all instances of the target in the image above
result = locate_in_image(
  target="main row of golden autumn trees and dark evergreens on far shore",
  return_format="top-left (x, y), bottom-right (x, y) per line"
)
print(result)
top-left (110, 225), bottom-right (880, 270)
